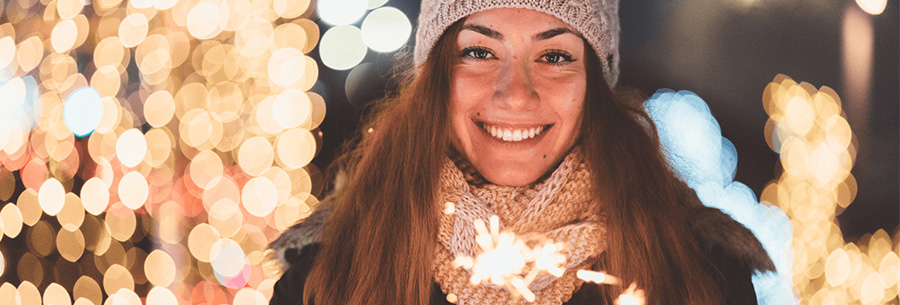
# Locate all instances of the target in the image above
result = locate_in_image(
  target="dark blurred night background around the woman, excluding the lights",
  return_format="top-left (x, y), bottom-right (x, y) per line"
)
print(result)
top-left (310, 0), bottom-right (900, 241)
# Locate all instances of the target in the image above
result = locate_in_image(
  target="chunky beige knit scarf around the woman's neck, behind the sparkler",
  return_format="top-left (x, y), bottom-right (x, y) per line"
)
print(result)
top-left (433, 147), bottom-right (606, 305)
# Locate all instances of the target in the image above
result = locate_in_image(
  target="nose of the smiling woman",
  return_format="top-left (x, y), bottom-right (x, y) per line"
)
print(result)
top-left (491, 58), bottom-right (539, 110)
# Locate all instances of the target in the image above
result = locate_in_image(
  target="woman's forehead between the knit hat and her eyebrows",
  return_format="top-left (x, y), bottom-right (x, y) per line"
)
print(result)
top-left (463, 8), bottom-right (580, 36)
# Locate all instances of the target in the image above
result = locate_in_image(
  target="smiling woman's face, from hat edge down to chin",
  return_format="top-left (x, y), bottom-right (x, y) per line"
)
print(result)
top-left (450, 8), bottom-right (587, 186)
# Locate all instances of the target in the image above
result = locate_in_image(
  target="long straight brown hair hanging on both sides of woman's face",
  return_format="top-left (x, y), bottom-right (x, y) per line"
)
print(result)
top-left (304, 21), bottom-right (721, 305)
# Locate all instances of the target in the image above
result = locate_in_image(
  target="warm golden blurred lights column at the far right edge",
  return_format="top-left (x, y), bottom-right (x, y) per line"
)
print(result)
top-left (761, 75), bottom-right (900, 305)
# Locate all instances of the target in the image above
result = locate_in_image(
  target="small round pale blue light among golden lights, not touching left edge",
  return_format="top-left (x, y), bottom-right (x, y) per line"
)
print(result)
top-left (63, 87), bottom-right (103, 137)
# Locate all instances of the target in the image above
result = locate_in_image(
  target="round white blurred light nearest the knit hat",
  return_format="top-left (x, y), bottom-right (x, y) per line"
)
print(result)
top-left (362, 7), bottom-right (412, 53)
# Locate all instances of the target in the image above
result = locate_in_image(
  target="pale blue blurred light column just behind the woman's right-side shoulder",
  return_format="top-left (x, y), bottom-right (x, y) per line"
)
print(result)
top-left (644, 89), bottom-right (798, 304)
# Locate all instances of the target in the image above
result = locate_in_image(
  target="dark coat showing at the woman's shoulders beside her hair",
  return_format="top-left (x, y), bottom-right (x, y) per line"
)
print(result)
top-left (270, 207), bottom-right (775, 305)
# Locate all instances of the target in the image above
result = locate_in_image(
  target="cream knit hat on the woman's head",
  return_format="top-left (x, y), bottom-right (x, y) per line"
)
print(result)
top-left (414, 0), bottom-right (620, 87)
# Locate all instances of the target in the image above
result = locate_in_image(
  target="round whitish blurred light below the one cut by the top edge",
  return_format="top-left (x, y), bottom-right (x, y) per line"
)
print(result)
top-left (319, 25), bottom-right (368, 70)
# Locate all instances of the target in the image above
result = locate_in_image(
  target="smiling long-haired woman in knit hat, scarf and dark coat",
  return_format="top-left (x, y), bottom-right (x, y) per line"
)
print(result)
top-left (272, 0), bottom-right (774, 304)
